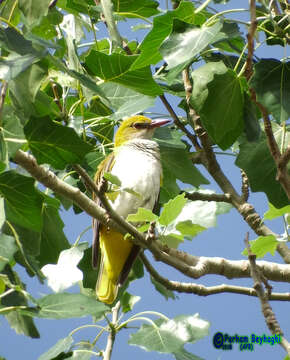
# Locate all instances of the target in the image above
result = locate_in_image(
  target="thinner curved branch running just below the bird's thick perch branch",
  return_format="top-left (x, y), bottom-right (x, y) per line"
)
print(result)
top-left (140, 253), bottom-right (290, 301)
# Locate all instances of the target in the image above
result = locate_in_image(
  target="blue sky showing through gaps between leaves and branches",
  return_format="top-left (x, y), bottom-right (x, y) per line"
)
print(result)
top-left (0, 0), bottom-right (290, 360)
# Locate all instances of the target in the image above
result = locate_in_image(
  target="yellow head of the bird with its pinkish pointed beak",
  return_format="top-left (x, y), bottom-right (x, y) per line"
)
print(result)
top-left (115, 115), bottom-right (170, 147)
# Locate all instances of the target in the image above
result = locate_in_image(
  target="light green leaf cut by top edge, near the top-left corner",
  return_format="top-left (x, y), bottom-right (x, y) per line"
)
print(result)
top-left (18, 0), bottom-right (50, 26)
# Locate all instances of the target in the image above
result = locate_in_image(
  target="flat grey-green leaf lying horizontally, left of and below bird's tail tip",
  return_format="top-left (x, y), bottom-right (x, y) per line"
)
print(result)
top-left (24, 293), bottom-right (108, 319)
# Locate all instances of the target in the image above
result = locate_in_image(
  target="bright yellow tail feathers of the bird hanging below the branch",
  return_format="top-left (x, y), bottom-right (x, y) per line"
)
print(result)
top-left (96, 225), bottom-right (133, 304)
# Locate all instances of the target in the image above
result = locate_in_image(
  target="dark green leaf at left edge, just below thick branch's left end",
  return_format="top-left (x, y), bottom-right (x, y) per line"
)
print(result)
top-left (0, 170), bottom-right (43, 231)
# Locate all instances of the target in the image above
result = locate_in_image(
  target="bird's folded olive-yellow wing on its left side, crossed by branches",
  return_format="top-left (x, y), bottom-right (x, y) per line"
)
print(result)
top-left (92, 152), bottom-right (115, 269)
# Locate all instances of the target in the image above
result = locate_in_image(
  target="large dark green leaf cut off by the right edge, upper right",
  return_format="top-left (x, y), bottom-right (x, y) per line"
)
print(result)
top-left (251, 59), bottom-right (290, 123)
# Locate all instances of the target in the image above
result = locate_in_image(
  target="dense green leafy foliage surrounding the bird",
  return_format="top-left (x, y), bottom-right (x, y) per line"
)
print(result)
top-left (0, 0), bottom-right (290, 360)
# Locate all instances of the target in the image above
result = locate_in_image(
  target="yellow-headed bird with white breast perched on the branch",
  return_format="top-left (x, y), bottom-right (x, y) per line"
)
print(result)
top-left (92, 115), bottom-right (170, 304)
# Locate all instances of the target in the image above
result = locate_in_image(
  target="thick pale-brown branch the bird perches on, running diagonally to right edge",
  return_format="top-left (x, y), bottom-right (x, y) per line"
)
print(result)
top-left (14, 150), bottom-right (290, 290)
